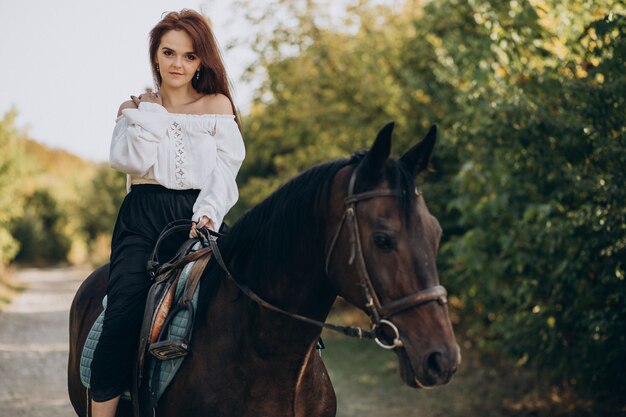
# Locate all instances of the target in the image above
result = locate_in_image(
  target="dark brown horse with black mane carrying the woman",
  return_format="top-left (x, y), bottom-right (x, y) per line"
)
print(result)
top-left (68, 123), bottom-right (460, 417)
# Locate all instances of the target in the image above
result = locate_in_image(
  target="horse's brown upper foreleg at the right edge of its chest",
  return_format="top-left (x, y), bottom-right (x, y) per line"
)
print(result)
top-left (294, 343), bottom-right (337, 417)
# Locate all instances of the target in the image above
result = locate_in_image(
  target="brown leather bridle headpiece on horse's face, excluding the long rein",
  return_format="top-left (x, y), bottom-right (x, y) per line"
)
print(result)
top-left (325, 168), bottom-right (448, 349)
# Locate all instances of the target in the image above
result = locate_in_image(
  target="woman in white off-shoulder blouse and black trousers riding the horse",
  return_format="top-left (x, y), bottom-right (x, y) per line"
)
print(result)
top-left (91, 10), bottom-right (245, 417)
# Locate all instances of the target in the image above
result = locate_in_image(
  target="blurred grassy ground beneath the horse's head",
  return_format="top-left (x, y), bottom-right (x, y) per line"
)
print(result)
top-left (322, 307), bottom-right (593, 417)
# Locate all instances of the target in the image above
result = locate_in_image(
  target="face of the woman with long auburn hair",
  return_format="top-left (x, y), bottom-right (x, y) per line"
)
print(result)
top-left (157, 30), bottom-right (200, 88)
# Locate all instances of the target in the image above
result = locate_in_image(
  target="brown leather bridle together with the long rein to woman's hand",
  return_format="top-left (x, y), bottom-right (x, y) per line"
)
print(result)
top-left (201, 164), bottom-right (448, 349)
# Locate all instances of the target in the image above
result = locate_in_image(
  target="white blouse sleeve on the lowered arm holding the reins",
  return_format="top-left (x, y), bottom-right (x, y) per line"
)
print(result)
top-left (192, 120), bottom-right (246, 229)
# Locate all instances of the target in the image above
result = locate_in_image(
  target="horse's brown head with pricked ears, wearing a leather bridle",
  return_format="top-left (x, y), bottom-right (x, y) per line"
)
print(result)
top-left (326, 124), bottom-right (460, 388)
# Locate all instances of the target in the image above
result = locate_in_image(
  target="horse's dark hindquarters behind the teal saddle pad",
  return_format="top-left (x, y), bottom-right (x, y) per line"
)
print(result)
top-left (67, 264), bottom-right (109, 417)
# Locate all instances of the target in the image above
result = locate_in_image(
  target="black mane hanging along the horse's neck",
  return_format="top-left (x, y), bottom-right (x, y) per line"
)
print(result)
top-left (220, 158), bottom-right (358, 285)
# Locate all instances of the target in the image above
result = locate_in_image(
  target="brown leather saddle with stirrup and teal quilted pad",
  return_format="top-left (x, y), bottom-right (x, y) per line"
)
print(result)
top-left (80, 220), bottom-right (217, 416)
